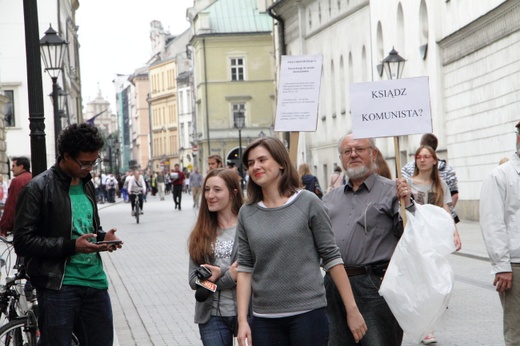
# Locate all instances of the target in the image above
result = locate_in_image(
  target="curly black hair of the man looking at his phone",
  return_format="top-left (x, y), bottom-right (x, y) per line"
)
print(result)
top-left (58, 123), bottom-right (104, 159)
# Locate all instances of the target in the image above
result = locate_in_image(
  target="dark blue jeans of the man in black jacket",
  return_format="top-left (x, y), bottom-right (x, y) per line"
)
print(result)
top-left (36, 286), bottom-right (114, 346)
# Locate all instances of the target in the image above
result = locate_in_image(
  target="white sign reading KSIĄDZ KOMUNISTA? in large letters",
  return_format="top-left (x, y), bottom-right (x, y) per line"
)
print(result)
top-left (350, 77), bottom-right (432, 138)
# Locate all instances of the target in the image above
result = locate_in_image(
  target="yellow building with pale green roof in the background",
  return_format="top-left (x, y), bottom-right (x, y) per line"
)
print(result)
top-left (190, 0), bottom-right (275, 172)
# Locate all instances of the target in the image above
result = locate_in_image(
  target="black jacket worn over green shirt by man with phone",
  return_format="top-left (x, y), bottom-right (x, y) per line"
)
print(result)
top-left (14, 164), bottom-right (105, 290)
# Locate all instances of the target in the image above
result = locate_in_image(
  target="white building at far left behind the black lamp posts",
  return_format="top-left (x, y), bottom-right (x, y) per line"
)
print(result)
top-left (0, 0), bottom-right (82, 167)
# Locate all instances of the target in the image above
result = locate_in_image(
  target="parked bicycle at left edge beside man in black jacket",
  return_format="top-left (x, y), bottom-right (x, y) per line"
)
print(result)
top-left (0, 236), bottom-right (38, 346)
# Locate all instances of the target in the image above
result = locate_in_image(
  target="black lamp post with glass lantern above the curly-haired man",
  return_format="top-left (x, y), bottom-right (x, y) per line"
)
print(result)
top-left (40, 25), bottom-right (68, 156)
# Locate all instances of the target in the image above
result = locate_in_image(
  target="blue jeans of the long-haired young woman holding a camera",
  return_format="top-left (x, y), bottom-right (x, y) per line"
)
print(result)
top-left (199, 316), bottom-right (237, 346)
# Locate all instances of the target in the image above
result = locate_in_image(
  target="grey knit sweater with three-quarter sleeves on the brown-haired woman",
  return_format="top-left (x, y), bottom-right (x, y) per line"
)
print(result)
top-left (237, 190), bottom-right (343, 314)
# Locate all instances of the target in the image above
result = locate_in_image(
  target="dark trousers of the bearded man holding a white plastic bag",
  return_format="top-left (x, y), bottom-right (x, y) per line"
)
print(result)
top-left (324, 274), bottom-right (403, 346)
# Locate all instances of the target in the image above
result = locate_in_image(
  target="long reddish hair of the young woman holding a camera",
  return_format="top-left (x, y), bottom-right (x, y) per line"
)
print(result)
top-left (188, 168), bottom-right (244, 265)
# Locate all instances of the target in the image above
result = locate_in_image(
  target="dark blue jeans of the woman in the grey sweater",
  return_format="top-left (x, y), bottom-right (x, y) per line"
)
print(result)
top-left (251, 308), bottom-right (329, 346)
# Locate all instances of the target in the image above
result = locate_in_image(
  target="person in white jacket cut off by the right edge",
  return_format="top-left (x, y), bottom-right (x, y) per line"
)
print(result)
top-left (480, 122), bottom-right (520, 346)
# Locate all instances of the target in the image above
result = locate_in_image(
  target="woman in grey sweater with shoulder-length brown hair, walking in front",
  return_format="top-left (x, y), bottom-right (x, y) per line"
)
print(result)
top-left (237, 137), bottom-right (366, 346)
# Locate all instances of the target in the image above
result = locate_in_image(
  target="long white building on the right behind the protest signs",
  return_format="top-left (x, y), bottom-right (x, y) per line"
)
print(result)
top-left (268, 0), bottom-right (520, 220)
